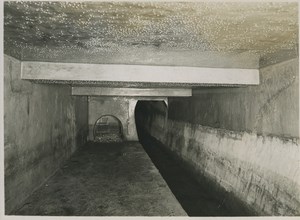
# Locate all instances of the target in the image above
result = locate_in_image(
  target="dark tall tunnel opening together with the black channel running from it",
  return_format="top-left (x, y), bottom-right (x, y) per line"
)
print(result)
top-left (135, 101), bottom-right (255, 216)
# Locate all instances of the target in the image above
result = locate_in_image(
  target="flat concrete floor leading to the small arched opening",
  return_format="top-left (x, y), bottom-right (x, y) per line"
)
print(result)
top-left (12, 142), bottom-right (186, 216)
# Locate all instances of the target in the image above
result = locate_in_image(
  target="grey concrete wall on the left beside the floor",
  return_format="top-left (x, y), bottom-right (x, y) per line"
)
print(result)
top-left (4, 55), bottom-right (87, 214)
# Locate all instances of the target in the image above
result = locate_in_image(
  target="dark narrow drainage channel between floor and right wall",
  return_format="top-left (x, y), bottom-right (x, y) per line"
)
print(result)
top-left (138, 129), bottom-right (256, 216)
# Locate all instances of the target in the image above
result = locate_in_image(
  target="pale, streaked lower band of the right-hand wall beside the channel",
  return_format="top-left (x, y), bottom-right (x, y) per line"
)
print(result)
top-left (138, 102), bottom-right (300, 215)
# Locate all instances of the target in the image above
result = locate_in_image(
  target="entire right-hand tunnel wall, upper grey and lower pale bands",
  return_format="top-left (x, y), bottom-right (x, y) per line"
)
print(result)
top-left (142, 59), bottom-right (300, 215)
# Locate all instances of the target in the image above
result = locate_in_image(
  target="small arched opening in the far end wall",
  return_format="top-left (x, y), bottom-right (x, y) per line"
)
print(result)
top-left (94, 115), bottom-right (123, 142)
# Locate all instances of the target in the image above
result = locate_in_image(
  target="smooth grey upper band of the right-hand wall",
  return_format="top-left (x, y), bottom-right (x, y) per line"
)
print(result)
top-left (169, 59), bottom-right (299, 138)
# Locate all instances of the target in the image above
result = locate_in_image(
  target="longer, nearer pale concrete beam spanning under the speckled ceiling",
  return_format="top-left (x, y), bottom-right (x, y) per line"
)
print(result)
top-left (22, 61), bottom-right (259, 85)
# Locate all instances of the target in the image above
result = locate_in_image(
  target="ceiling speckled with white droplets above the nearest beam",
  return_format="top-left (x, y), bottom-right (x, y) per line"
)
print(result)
top-left (4, 2), bottom-right (298, 68)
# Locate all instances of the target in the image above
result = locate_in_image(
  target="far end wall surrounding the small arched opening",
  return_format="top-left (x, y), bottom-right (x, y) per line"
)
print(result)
top-left (88, 96), bottom-right (138, 141)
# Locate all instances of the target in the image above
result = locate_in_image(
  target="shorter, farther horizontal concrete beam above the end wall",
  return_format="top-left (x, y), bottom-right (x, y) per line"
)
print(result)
top-left (72, 87), bottom-right (192, 97)
